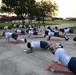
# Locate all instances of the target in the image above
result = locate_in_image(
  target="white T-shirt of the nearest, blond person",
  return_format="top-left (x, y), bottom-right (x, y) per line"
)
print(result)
top-left (54, 48), bottom-right (71, 66)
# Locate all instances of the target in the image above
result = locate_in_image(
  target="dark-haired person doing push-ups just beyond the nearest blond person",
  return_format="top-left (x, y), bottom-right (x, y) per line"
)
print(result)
top-left (24, 41), bottom-right (50, 53)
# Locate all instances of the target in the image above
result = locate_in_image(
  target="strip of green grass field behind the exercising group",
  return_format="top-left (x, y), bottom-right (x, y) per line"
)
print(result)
top-left (0, 21), bottom-right (76, 30)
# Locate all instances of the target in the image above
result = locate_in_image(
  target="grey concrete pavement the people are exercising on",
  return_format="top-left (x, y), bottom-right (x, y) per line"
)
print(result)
top-left (0, 24), bottom-right (76, 75)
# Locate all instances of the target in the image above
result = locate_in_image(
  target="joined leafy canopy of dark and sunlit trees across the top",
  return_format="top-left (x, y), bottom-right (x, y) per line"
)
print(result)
top-left (1, 0), bottom-right (58, 23)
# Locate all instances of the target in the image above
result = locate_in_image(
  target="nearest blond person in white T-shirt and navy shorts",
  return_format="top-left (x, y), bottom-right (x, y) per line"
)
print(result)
top-left (49, 44), bottom-right (76, 75)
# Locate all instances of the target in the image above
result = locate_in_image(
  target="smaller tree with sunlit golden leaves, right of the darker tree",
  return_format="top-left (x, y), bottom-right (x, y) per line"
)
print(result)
top-left (38, 0), bottom-right (58, 23)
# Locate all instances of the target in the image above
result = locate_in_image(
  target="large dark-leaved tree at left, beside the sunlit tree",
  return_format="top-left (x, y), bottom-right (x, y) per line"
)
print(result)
top-left (2, 0), bottom-right (35, 23)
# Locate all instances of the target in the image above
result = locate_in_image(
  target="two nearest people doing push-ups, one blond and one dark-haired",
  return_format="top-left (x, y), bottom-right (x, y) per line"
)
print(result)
top-left (24, 41), bottom-right (76, 75)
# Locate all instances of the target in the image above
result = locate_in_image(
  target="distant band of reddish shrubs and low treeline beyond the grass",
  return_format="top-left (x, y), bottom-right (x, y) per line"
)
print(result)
top-left (0, 15), bottom-right (76, 22)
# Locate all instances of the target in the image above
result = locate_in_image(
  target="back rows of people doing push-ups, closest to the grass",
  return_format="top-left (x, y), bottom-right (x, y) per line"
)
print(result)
top-left (0, 25), bottom-right (75, 41)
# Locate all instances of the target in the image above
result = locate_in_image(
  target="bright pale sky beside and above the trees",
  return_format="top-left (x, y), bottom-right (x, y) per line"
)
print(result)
top-left (0, 0), bottom-right (76, 18)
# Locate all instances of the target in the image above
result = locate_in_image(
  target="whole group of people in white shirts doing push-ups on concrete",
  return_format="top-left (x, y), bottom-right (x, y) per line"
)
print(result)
top-left (0, 26), bottom-right (76, 75)
